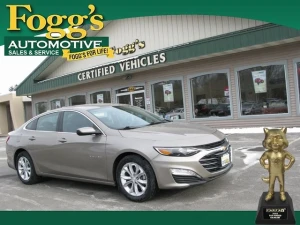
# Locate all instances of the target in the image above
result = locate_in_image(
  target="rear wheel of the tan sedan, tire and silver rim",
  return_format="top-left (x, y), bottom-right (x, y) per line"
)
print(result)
top-left (16, 151), bottom-right (41, 185)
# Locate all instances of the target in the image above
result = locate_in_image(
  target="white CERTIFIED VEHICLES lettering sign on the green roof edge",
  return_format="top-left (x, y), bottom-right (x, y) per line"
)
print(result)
top-left (77, 52), bottom-right (167, 81)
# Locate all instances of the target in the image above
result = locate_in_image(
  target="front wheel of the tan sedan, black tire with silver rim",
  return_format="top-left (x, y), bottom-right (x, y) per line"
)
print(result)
top-left (116, 155), bottom-right (158, 202)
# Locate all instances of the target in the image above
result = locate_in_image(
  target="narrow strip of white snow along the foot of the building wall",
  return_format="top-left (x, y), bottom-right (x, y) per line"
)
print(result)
top-left (218, 127), bottom-right (300, 134)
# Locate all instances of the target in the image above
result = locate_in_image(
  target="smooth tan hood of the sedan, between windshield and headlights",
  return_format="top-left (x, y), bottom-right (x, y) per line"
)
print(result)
top-left (120, 122), bottom-right (225, 146)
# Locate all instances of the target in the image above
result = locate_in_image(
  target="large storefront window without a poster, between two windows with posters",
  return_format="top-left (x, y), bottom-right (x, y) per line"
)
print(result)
top-left (190, 73), bottom-right (231, 118)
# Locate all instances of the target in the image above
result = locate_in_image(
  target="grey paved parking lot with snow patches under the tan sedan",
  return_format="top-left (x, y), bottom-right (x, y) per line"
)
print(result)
top-left (0, 133), bottom-right (300, 211)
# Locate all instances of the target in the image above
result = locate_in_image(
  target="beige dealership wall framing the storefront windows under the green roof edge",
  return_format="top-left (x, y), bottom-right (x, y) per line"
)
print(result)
top-left (32, 42), bottom-right (300, 128)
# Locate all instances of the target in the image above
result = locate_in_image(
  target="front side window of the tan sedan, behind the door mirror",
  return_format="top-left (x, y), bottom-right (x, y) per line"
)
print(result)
top-left (62, 112), bottom-right (98, 133)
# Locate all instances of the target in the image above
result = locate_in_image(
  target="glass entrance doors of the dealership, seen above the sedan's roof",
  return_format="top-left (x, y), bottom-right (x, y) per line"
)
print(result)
top-left (116, 86), bottom-right (145, 109)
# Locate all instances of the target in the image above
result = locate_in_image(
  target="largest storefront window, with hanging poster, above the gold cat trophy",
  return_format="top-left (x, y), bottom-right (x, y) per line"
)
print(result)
top-left (238, 65), bottom-right (288, 116)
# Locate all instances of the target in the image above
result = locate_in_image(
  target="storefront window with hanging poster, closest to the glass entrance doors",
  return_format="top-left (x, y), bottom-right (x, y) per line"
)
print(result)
top-left (152, 80), bottom-right (185, 120)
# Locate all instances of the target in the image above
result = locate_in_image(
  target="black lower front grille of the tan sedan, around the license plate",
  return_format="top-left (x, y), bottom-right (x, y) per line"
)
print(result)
top-left (199, 147), bottom-right (232, 173)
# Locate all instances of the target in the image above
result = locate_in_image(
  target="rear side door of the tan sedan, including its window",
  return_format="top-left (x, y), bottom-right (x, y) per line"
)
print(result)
top-left (22, 112), bottom-right (59, 173)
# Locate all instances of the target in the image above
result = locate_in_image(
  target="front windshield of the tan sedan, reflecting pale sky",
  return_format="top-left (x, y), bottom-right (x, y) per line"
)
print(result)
top-left (89, 106), bottom-right (168, 130)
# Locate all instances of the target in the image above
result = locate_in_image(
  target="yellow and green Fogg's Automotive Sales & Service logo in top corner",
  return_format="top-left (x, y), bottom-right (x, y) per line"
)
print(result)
top-left (4, 4), bottom-right (114, 60)
